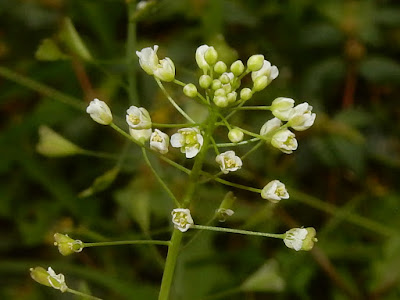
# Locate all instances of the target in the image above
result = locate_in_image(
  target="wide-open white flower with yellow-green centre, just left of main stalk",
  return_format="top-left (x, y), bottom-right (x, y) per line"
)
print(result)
top-left (171, 127), bottom-right (203, 158)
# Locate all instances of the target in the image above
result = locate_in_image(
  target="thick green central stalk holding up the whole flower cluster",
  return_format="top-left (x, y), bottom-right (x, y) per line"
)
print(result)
top-left (158, 110), bottom-right (217, 300)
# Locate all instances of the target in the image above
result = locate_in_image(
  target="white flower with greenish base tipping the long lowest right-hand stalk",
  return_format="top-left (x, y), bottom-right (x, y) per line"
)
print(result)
top-left (283, 227), bottom-right (318, 251)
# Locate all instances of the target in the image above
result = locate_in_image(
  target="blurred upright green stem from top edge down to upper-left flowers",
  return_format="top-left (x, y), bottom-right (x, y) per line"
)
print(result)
top-left (126, 0), bottom-right (139, 106)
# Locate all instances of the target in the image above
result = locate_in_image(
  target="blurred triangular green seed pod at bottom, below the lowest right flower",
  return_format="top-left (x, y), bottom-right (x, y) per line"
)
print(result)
top-left (240, 259), bottom-right (285, 292)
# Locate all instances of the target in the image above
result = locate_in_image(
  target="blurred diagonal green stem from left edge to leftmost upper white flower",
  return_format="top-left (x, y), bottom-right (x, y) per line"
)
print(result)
top-left (0, 66), bottom-right (85, 111)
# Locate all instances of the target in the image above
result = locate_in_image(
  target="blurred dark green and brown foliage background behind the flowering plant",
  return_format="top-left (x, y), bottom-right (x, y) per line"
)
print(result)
top-left (0, 0), bottom-right (400, 300)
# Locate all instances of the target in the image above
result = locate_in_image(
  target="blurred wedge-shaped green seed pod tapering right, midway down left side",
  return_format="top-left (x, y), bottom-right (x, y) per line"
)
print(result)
top-left (36, 125), bottom-right (82, 157)
